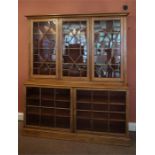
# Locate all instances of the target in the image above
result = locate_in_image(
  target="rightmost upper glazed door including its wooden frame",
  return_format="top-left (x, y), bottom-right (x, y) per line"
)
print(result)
top-left (92, 18), bottom-right (126, 81)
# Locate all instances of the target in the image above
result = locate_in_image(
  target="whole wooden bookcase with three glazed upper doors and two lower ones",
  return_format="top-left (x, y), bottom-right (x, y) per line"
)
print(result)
top-left (24, 13), bottom-right (130, 145)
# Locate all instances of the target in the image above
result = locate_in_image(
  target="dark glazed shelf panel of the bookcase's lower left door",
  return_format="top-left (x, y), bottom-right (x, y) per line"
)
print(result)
top-left (26, 87), bottom-right (72, 130)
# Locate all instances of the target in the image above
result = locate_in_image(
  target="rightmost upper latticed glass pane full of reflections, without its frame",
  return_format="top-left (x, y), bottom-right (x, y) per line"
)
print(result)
top-left (94, 20), bottom-right (121, 78)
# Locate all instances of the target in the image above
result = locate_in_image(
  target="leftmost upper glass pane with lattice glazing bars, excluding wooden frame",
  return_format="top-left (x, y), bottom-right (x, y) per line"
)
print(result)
top-left (33, 20), bottom-right (56, 75)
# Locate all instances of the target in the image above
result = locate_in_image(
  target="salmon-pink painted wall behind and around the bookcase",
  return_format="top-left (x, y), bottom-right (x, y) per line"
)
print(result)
top-left (18, 0), bottom-right (136, 122)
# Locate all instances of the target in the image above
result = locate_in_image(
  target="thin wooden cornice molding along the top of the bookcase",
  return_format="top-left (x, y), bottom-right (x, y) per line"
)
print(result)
top-left (25, 12), bottom-right (129, 19)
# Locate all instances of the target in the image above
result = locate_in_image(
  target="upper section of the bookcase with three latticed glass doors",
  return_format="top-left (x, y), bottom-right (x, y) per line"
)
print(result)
top-left (28, 14), bottom-right (127, 82)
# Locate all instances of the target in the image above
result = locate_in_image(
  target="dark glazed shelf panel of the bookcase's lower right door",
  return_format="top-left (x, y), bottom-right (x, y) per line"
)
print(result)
top-left (76, 89), bottom-right (127, 134)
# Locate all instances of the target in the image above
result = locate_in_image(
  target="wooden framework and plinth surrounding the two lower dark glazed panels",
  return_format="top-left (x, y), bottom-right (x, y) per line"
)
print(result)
top-left (24, 84), bottom-right (130, 145)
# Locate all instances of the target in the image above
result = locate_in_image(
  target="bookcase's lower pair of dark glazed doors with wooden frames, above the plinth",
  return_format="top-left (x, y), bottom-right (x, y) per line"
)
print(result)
top-left (25, 85), bottom-right (128, 145)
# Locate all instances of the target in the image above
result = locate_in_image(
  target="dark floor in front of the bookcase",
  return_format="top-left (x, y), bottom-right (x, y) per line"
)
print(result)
top-left (18, 122), bottom-right (136, 155)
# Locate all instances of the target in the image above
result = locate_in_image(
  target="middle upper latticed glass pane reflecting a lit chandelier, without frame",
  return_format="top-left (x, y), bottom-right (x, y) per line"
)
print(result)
top-left (62, 21), bottom-right (88, 77)
